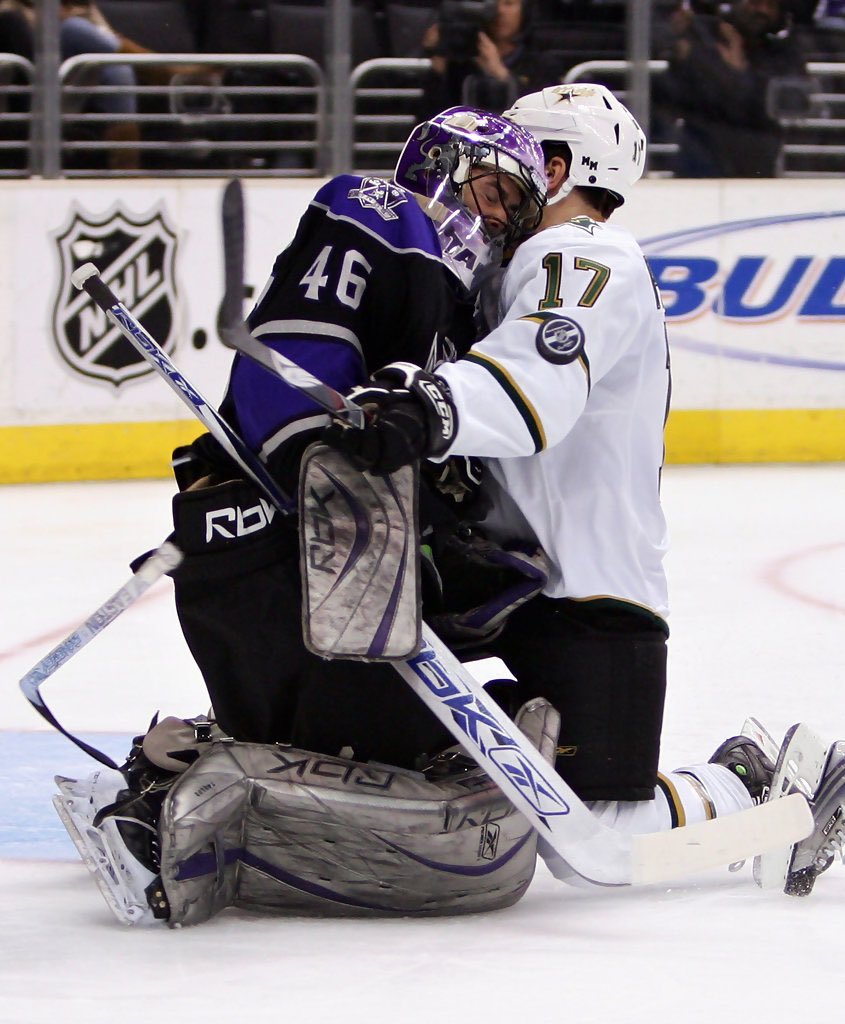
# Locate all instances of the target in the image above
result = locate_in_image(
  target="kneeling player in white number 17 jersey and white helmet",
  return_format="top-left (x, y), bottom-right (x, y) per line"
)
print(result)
top-left (326, 84), bottom-right (843, 892)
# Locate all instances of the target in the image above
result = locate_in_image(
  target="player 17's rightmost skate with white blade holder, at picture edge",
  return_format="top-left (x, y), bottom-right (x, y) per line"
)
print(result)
top-left (754, 724), bottom-right (845, 896)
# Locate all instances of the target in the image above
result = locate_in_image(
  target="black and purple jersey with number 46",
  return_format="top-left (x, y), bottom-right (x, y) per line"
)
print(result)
top-left (222, 175), bottom-right (473, 492)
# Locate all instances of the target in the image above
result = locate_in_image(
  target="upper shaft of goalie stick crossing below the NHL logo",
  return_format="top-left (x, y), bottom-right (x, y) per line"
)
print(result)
top-left (71, 263), bottom-right (296, 513)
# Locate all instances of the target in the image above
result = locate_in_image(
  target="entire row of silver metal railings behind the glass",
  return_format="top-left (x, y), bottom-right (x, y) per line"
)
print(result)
top-left (0, 52), bottom-right (845, 177)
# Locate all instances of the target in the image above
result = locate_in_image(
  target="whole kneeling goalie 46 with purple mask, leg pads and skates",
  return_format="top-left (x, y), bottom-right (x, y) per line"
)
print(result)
top-left (56, 108), bottom-right (555, 923)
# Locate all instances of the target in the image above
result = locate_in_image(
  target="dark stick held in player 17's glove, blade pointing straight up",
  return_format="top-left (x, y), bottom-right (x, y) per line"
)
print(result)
top-left (217, 178), bottom-right (365, 427)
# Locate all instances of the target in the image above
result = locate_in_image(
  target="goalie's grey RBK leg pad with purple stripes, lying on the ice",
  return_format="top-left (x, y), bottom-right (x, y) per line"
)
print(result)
top-left (160, 700), bottom-right (559, 926)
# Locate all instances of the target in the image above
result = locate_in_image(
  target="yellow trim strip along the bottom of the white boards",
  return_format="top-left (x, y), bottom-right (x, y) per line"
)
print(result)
top-left (0, 409), bottom-right (845, 483)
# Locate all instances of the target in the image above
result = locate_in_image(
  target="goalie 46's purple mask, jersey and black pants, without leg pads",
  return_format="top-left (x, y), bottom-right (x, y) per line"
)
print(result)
top-left (174, 108), bottom-right (545, 767)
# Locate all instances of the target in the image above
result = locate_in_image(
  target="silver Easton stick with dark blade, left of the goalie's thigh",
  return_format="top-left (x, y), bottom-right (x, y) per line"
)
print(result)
top-left (20, 541), bottom-right (182, 768)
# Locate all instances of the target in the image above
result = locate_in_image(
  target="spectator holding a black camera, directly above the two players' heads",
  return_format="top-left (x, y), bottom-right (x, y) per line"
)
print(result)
top-left (419, 0), bottom-right (544, 121)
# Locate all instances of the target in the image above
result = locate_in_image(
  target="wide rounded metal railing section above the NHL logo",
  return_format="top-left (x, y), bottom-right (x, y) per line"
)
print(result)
top-left (59, 53), bottom-right (326, 176)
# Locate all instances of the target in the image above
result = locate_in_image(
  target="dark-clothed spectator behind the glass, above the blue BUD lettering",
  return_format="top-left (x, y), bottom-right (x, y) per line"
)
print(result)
top-left (654, 0), bottom-right (806, 178)
